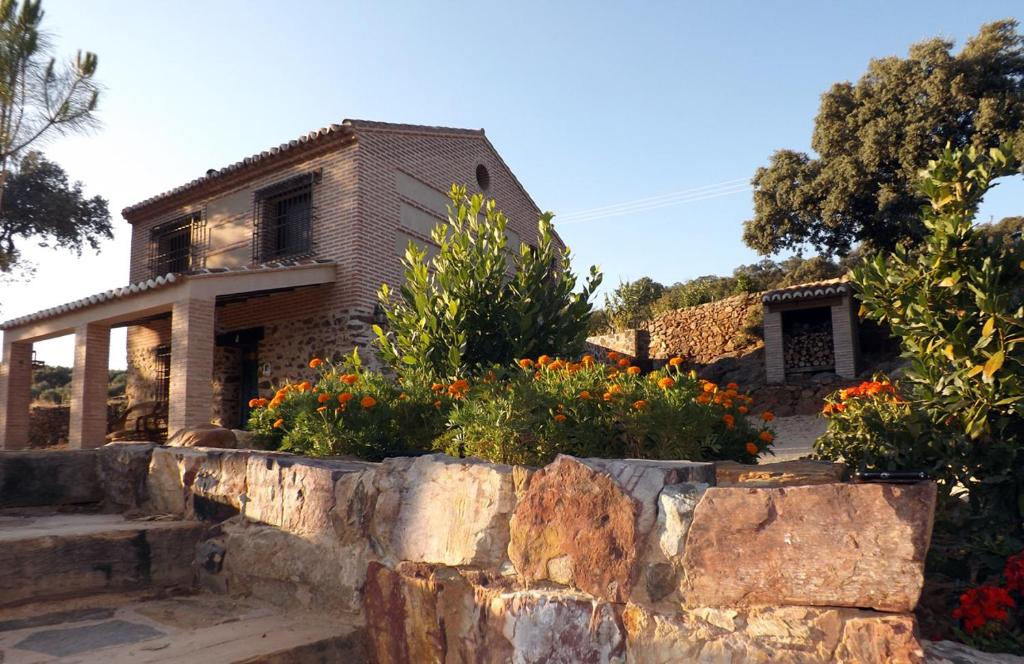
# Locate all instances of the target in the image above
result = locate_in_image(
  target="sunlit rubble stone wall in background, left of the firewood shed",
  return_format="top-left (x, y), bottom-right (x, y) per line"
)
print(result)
top-left (647, 293), bottom-right (763, 364)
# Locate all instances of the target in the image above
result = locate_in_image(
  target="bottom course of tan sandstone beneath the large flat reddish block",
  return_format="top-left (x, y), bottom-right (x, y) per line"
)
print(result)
top-left (623, 605), bottom-right (923, 664)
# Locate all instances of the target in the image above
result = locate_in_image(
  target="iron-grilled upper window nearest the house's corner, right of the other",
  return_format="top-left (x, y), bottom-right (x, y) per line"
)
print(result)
top-left (253, 170), bottom-right (321, 263)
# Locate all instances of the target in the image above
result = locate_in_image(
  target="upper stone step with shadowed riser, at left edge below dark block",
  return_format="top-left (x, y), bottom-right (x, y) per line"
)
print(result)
top-left (0, 509), bottom-right (204, 608)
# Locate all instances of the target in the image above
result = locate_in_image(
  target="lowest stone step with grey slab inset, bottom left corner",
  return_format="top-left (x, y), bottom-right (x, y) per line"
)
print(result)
top-left (0, 593), bottom-right (367, 664)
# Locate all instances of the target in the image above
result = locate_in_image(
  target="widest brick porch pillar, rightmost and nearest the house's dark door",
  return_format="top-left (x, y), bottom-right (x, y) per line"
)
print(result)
top-left (167, 299), bottom-right (215, 434)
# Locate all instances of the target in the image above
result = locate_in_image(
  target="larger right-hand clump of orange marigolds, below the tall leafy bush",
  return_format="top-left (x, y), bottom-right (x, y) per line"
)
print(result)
top-left (437, 354), bottom-right (772, 465)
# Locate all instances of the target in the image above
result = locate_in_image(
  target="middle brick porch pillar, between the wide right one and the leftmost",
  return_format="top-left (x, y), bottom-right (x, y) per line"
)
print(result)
top-left (68, 323), bottom-right (111, 450)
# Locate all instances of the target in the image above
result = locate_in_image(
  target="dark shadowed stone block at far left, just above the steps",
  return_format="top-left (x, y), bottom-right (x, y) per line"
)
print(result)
top-left (0, 450), bottom-right (103, 507)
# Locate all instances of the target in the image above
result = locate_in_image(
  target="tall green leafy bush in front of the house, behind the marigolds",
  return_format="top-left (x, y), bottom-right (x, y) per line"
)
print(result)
top-left (374, 186), bottom-right (601, 378)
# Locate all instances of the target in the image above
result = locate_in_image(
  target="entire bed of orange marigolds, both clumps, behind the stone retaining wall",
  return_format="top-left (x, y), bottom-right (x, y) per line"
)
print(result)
top-left (249, 354), bottom-right (773, 465)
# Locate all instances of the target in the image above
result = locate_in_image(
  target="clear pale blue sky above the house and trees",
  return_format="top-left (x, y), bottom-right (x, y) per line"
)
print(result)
top-left (0, 0), bottom-right (1024, 366)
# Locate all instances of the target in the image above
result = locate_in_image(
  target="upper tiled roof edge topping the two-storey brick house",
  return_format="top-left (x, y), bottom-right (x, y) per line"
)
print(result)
top-left (121, 119), bottom-right (487, 218)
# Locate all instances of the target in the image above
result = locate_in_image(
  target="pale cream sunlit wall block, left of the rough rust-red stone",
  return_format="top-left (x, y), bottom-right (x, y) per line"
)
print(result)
top-left (370, 454), bottom-right (515, 569)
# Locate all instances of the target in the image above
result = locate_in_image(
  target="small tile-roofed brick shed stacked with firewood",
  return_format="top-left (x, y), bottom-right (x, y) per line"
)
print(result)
top-left (761, 278), bottom-right (860, 383)
